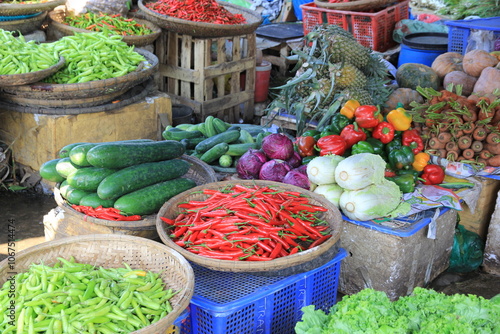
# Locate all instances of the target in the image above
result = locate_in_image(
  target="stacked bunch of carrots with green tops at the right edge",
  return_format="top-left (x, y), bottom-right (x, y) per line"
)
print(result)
top-left (413, 88), bottom-right (500, 168)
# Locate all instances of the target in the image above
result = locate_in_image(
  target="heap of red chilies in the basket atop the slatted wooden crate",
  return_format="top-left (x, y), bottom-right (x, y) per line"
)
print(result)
top-left (146, 0), bottom-right (246, 24)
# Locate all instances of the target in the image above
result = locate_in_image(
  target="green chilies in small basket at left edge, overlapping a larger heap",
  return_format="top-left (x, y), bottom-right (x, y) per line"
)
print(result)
top-left (0, 29), bottom-right (59, 75)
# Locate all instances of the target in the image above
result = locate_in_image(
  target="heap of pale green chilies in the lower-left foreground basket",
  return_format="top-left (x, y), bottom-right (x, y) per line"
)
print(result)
top-left (0, 258), bottom-right (177, 334)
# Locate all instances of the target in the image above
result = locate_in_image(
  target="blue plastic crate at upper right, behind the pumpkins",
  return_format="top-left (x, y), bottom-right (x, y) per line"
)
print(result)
top-left (445, 17), bottom-right (500, 54)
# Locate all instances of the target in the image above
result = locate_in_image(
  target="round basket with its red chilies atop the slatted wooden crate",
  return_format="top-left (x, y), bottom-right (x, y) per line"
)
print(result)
top-left (138, 0), bottom-right (262, 38)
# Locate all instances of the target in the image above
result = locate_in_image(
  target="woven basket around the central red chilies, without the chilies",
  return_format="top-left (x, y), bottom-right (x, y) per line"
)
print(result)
top-left (156, 180), bottom-right (342, 272)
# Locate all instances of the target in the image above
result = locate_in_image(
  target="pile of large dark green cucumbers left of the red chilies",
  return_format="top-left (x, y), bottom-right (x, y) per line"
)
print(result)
top-left (40, 139), bottom-right (196, 215)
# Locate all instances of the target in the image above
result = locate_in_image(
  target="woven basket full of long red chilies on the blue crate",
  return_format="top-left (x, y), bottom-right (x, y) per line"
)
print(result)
top-left (156, 180), bottom-right (342, 273)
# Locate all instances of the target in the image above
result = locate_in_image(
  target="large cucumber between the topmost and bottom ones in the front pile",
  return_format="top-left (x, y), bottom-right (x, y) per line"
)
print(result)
top-left (97, 159), bottom-right (190, 199)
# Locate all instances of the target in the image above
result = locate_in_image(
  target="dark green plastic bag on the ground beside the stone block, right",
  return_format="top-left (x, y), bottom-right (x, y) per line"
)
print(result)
top-left (447, 225), bottom-right (484, 273)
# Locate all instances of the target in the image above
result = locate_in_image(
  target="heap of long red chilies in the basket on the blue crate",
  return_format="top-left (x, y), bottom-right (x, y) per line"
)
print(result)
top-left (160, 185), bottom-right (331, 261)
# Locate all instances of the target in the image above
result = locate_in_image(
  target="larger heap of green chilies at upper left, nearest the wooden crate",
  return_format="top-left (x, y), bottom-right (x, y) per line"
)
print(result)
top-left (42, 32), bottom-right (146, 84)
